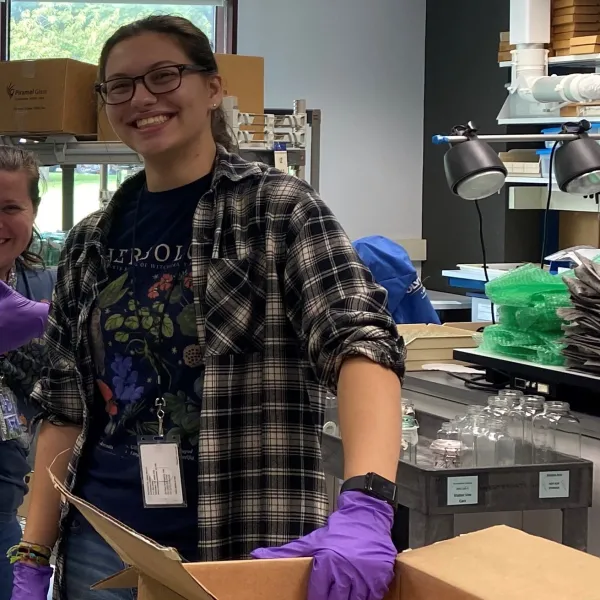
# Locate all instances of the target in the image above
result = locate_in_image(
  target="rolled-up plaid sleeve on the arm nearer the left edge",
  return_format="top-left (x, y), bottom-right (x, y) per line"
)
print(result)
top-left (31, 264), bottom-right (83, 426)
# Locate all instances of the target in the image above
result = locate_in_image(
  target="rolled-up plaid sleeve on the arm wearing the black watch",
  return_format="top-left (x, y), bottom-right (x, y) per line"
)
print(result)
top-left (284, 193), bottom-right (406, 390)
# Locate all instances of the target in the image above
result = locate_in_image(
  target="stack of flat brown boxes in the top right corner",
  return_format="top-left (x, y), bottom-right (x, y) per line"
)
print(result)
top-left (551, 0), bottom-right (600, 51)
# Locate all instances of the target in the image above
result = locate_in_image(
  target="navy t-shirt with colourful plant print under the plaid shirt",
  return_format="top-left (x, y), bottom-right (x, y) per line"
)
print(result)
top-left (78, 175), bottom-right (212, 560)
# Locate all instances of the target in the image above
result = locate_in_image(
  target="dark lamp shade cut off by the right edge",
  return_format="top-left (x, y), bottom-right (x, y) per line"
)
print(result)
top-left (554, 135), bottom-right (600, 196)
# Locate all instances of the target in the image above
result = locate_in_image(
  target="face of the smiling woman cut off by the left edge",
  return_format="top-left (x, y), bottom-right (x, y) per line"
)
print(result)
top-left (0, 171), bottom-right (35, 277)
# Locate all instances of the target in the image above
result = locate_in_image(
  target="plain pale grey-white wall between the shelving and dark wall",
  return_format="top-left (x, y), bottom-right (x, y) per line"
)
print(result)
top-left (238, 0), bottom-right (426, 240)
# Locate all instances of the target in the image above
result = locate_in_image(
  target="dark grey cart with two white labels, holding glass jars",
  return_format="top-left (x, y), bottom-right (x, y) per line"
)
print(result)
top-left (322, 411), bottom-right (593, 551)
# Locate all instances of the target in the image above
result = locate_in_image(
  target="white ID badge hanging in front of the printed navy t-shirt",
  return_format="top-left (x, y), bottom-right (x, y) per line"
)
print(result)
top-left (138, 436), bottom-right (187, 508)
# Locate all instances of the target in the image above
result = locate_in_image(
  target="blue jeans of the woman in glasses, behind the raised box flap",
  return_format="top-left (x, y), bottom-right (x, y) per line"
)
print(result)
top-left (63, 515), bottom-right (137, 600)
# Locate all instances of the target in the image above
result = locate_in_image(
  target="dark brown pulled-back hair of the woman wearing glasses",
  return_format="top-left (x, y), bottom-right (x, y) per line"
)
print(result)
top-left (98, 15), bottom-right (236, 151)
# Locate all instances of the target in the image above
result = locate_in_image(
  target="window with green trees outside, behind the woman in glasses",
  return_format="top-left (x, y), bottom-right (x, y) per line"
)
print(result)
top-left (0, 0), bottom-right (237, 232)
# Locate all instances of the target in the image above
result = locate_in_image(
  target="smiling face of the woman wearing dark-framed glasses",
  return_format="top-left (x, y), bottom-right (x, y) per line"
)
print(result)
top-left (104, 33), bottom-right (222, 158)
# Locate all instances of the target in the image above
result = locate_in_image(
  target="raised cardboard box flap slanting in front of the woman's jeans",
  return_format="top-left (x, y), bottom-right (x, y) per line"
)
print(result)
top-left (48, 469), bottom-right (216, 600)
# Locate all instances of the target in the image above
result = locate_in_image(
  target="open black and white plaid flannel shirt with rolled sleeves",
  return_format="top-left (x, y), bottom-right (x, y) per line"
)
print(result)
top-left (34, 147), bottom-right (405, 599)
